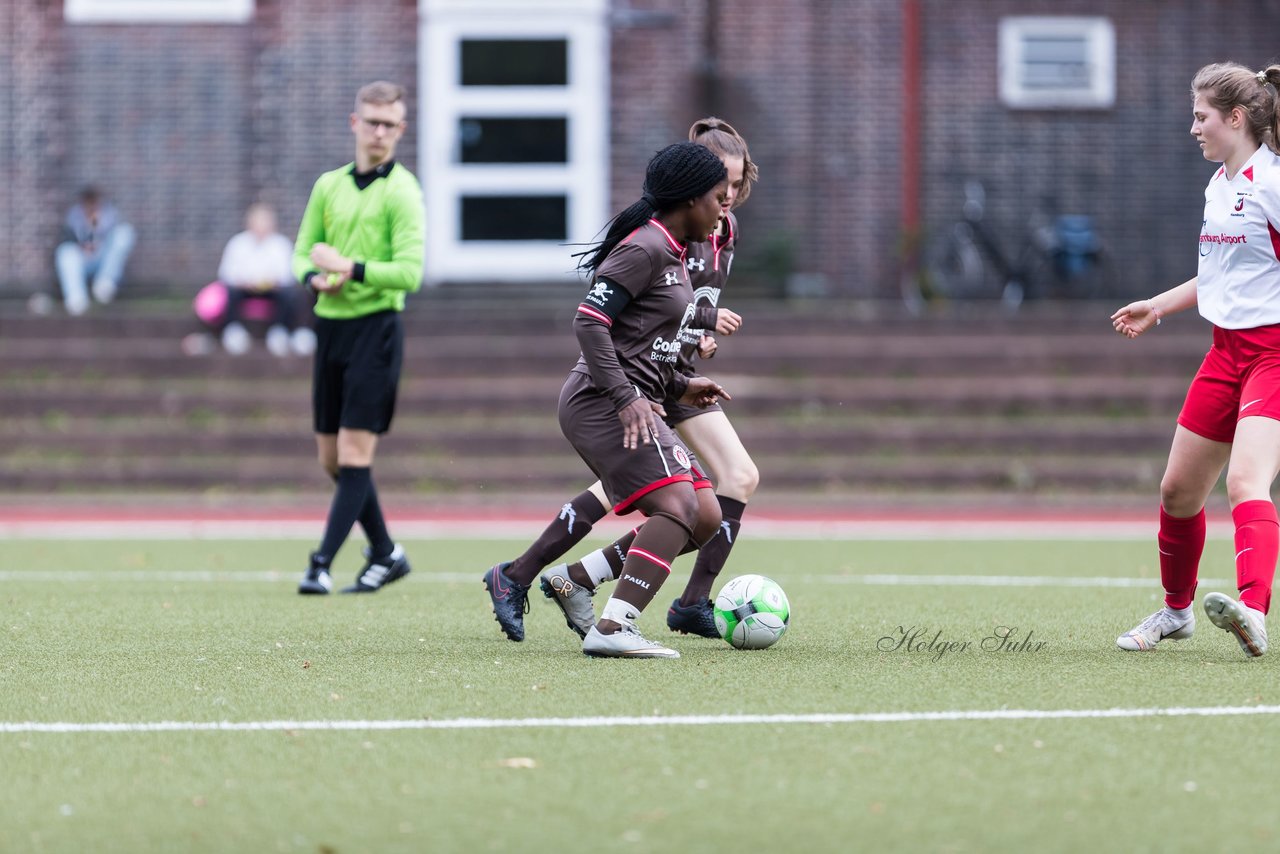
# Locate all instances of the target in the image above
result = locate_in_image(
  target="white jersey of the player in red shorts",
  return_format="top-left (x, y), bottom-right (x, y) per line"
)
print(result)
top-left (1196, 146), bottom-right (1280, 329)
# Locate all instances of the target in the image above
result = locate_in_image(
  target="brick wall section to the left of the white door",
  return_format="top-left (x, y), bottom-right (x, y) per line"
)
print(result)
top-left (0, 0), bottom-right (417, 292)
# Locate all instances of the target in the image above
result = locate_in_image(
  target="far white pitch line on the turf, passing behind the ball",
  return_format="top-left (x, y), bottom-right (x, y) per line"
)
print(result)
top-left (0, 570), bottom-right (1235, 589)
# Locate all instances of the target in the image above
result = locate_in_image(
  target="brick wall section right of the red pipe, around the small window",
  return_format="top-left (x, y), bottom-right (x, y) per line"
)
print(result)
top-left (922, 0), bottom-right (1280, 296)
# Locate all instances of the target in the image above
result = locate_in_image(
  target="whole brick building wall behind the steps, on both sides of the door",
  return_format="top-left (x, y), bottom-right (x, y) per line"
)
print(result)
top-left (0, 0), bottom-right (1280, 297)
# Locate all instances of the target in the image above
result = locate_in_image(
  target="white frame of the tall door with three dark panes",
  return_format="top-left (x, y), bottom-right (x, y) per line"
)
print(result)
top-left (417, 0), bottom-right (609, 286)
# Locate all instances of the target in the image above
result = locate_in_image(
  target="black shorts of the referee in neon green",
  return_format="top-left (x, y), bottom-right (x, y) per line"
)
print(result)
top-left (311, 311), bottom-right (404, 434)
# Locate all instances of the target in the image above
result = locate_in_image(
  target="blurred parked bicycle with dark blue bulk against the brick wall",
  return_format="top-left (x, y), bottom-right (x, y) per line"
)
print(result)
top-left (902, 181), bottom-right (1101, 314)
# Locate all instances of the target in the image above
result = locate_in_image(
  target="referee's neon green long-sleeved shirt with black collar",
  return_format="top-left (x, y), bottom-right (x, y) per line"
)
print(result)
top-left (293, 163), bottom-right (426, 320)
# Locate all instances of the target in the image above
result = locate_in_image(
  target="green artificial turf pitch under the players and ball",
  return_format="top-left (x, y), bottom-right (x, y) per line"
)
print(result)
top-left (0, 539), bottom-right (1280, 853)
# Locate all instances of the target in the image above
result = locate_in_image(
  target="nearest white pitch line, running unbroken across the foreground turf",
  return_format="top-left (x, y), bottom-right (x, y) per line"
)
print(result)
top-left (0, 705), bottom-right (1280, 735)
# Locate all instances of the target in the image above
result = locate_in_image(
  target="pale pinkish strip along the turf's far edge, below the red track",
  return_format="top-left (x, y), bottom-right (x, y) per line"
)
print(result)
top-left (0, 515), bottom-right (1231, 542)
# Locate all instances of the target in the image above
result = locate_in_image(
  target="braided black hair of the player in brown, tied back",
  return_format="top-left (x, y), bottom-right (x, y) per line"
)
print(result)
top-left (573, 142), bottom-right (728, 274)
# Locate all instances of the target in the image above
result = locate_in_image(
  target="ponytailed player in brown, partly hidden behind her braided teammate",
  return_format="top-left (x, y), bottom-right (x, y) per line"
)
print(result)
top-left (486, 117), bottom-right (759, 640)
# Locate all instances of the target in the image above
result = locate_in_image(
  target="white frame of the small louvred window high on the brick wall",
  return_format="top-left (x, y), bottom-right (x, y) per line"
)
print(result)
top-left (1000, 17), bottom-right (1116, 110)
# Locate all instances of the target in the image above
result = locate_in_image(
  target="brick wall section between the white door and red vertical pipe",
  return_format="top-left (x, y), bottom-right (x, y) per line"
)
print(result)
top-left (612, 0), bottom-right (901, 297)
